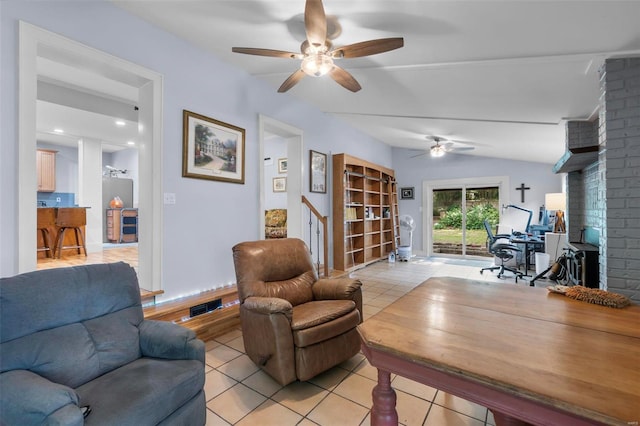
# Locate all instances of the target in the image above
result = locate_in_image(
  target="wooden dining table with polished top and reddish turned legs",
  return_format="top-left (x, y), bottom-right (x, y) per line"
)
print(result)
top-left (358, 277), bottom-right (640, 426)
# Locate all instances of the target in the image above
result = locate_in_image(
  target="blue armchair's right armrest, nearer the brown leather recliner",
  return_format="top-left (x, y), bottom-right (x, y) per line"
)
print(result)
top-left (139, 320), bottom-right (205, 364)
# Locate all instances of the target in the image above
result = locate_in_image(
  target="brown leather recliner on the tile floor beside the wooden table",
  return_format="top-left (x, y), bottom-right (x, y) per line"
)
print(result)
top-left (233, 238), bottom-right (362, 385)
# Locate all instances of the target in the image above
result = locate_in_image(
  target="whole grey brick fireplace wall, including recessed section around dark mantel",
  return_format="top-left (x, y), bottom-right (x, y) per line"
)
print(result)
top-left (567, 58), bottom-right (640, 302)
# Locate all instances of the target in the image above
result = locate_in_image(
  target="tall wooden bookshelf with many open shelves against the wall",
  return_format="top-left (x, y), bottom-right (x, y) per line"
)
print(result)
top-left (333, 154), bottom-right (398, 271)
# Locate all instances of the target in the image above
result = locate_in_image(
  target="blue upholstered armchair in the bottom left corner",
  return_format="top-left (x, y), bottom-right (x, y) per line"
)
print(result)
top-left (0, 262), bottom-right (206, 426)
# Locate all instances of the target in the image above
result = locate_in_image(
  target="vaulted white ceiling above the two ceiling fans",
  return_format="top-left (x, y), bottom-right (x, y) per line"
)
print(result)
top-left (37, 0), bottom-right (640, 164)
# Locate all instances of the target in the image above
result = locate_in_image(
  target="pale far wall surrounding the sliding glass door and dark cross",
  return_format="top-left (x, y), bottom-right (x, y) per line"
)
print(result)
top-left (393, 148), bottom-right (562, 252)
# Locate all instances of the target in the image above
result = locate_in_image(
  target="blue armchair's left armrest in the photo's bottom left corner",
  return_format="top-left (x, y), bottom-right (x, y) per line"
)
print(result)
top-left (0, 370), bottom-right (84, 426)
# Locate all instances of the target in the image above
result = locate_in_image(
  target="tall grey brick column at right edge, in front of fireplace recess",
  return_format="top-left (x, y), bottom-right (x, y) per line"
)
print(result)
top-left (598, 58), bottom-right (640, 302)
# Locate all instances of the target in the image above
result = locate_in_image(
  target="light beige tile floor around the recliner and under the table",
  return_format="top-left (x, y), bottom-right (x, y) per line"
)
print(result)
top-left (205, 258), bottom-right (547, 426)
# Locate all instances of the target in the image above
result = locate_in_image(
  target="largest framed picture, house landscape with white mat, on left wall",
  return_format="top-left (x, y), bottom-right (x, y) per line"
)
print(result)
top-left (182, 110), bottom-right (245, 184)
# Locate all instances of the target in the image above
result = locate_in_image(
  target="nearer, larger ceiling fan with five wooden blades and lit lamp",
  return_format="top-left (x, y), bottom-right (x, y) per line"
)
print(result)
top-left (231, 0), bottom-right (404, 93)
